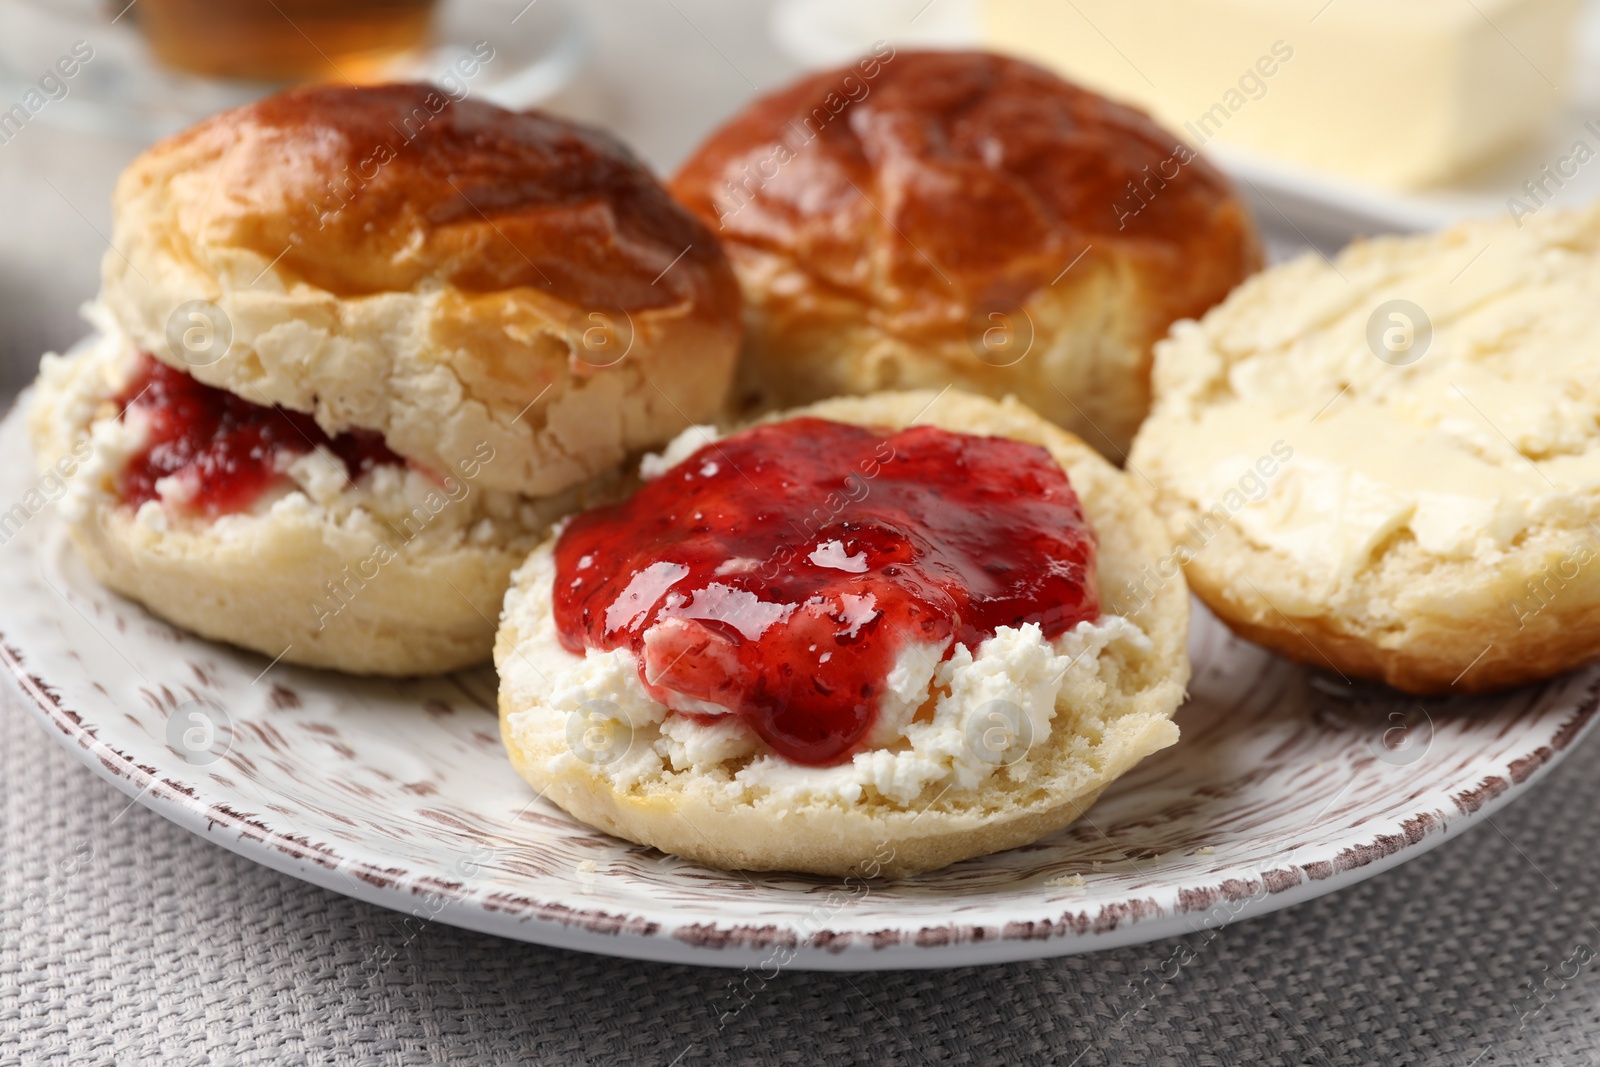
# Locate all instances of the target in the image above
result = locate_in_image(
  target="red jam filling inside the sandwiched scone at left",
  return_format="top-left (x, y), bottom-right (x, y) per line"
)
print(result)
top-left (117, 355), bottom-right (405, 518)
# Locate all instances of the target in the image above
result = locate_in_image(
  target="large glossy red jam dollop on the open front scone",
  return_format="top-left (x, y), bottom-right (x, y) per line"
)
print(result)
top-left (555, 419), bottom-right (1099, 765)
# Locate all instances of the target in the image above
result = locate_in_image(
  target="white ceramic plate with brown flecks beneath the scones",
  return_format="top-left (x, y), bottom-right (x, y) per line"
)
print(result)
top-left (0, 404), bottom-right (1600, 974)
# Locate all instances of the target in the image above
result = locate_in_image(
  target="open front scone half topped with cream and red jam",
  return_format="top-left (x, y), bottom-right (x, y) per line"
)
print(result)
top-left (494, 392), bottom-right (1189, 877)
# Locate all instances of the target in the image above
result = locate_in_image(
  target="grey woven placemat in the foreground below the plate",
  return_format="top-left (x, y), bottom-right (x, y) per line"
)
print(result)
top-left (0, 680), bottom-right (1600, 1067)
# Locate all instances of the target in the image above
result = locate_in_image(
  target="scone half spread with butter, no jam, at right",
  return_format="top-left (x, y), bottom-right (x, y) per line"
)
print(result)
top-left (1132, 208), bottom-right (1600, 693)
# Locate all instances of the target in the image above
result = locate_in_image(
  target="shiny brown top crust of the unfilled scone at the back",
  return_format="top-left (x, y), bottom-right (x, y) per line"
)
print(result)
top-left (672, 50), bottom-right (1258, 341)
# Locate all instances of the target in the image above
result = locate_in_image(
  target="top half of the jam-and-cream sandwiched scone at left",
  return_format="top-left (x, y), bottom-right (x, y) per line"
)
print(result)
top-left (102, 85), bottom-right (739, 494)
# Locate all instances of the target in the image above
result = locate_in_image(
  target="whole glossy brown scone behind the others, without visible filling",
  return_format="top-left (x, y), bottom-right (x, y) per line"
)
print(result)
top-left (672, 46), bottom-right (1261, 462)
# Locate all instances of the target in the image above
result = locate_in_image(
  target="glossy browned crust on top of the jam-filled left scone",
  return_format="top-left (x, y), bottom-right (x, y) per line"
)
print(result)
top-left (129, 85), bottom-right (726, 310)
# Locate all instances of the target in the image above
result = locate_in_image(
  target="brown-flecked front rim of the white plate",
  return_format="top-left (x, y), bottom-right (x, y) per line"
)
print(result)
top-left (12, 390), bottom-right (1600, 971)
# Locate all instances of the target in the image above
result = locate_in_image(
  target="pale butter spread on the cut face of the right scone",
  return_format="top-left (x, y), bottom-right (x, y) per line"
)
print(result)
top-left (1136, 211), bottom-right (1600, 592)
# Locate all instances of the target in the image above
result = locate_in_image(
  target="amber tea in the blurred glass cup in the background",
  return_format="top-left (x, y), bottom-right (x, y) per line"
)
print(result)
top-left (128, 0), bottom-right (435, 82)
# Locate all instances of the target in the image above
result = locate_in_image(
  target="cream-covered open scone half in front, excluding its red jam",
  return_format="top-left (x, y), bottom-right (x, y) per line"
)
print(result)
top-left (494, 392), bottom-right (1189, 877)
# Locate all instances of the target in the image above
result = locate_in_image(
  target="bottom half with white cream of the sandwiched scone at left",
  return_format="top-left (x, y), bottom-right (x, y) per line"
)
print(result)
top-left (29, 315), bottom-right (614, 675)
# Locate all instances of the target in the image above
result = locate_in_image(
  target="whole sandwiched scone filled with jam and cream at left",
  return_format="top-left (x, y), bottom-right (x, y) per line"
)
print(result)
top-left (30, 85), bottom-right (739, 675)
